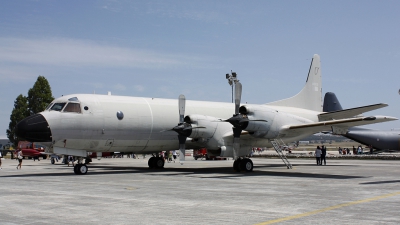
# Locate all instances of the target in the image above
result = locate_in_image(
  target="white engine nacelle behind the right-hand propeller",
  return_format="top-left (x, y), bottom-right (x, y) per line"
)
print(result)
top-left (239, 105), bottom-right (277, 138)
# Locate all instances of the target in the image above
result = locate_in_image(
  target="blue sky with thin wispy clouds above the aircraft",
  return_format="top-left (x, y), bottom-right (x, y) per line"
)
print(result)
top-left (0, 0), bottom-right (400, 137)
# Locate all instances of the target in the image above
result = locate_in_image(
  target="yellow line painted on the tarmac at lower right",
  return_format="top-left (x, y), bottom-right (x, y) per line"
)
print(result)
top-left (256, 191), bottom-right (400, 225)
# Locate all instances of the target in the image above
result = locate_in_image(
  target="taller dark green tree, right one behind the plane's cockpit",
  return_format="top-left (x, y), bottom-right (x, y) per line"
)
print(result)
top-left (28, 76), bottom-right (54, 114)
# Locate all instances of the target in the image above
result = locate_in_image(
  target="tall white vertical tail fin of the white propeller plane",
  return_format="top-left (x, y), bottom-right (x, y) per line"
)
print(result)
top-left (267, 54), bottom-right (322, 112)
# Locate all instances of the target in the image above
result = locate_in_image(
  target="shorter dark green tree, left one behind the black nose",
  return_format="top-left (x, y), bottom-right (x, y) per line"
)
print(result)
top-left (7, 94), bottom-right (30, 146)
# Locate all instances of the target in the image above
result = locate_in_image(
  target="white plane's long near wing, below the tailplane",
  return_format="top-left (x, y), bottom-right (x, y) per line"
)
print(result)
top-left (279, 116), bottom-right (397, 137)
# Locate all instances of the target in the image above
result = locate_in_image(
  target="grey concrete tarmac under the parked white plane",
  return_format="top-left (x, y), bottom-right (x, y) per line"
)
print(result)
top-left (0, 157), bottom-right (400, 224)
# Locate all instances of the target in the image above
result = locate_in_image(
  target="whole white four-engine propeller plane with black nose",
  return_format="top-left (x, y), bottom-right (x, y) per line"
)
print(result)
top-left (16, 55), bottom-right (397, 174)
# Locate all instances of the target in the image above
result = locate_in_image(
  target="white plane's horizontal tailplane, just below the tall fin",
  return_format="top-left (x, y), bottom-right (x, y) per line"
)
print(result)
top-left (318, 103), bottom-right (388, 121)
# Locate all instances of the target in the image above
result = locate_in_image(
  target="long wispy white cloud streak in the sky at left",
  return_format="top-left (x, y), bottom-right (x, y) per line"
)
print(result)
top-left (0, 38), bottom-right (190, 68)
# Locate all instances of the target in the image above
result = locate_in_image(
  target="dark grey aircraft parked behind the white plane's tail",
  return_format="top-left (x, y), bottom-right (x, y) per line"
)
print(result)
top-left (323, 92), bottom-right (400, 151)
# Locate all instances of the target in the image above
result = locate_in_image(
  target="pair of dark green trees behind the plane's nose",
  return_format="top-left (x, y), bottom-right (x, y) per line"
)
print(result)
top-left (7, 76), bottom-right (54, 146)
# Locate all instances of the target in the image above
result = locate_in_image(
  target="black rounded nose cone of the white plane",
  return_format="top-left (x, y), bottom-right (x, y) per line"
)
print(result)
top-left (15, 114), bottom-right (52, 142)
